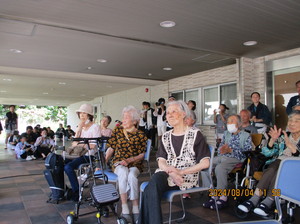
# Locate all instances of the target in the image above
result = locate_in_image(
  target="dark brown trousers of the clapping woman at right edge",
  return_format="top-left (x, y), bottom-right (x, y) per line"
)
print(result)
top-left (257, 159), bottom-right (281, 197)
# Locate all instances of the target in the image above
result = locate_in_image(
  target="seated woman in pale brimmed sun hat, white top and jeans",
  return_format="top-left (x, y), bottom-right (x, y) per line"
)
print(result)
top-left (64, 104), bottom-right (101, 201)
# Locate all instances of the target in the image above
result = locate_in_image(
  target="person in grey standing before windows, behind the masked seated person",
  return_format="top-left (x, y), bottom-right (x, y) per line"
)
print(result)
top-left (214, 104), bottom-right (229, 148)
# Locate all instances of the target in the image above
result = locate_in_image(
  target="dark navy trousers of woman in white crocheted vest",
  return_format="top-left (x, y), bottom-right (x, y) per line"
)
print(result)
top-left (138, 172), bottom-right (179, 224)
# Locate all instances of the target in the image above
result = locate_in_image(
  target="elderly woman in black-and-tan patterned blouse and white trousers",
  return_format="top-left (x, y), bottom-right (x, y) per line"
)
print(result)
top-left (106, 106), bottom-right (147, 223)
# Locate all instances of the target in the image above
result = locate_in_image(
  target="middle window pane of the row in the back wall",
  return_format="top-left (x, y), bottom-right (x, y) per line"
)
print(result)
top-left (203, 87), bottom-right (219, 124)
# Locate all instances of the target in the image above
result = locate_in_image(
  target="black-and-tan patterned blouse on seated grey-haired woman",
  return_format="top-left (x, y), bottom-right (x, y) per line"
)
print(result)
top-left (107, 127), bottom-right (147, 172)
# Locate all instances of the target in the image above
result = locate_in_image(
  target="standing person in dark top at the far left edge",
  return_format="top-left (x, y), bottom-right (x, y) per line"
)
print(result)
top-left (4, 105), bottom-right (18, 149)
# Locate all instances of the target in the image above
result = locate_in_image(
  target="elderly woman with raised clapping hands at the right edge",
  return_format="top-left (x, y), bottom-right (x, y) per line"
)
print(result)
top-left (238, 111), bottom-right (300, 216)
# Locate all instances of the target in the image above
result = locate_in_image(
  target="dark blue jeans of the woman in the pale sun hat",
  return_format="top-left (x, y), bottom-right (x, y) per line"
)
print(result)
top-left (64, 156), bottom-right (89, 193)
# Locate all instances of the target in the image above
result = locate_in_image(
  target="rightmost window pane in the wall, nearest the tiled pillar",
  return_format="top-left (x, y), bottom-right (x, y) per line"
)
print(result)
top-left (220, 83), bottom-right (237, 114)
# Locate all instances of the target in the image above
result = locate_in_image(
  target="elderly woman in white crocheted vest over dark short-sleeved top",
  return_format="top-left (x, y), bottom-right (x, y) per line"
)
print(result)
top-left (138, 101), bottom-right (210, 224)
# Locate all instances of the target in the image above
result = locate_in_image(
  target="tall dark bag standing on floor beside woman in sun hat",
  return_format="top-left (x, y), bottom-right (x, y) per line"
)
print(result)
top-left (44, 153), bottom-right (65, 204)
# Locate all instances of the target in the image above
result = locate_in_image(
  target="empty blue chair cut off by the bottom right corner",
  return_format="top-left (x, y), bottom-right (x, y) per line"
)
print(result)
top-left (223, 157), bottom-right (300, 224)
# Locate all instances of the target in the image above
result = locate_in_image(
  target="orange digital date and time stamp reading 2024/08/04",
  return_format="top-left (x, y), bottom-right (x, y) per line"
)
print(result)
top-left (209, 188), bottom-right (281, 197)
